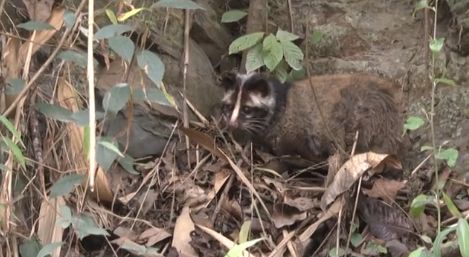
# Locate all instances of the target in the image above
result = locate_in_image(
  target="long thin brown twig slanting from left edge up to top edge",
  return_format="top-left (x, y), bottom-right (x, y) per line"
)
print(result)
top-left (2, 0), bottom-right (86, 116)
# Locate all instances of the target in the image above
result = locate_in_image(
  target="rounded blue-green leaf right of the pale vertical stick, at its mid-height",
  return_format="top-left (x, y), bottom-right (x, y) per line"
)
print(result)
top-left (103, 83), bottom-right (130, 114)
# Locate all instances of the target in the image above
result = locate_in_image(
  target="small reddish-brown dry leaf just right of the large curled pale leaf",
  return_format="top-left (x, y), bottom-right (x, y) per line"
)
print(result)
top-left (363, 178), bottom-right (406, 203)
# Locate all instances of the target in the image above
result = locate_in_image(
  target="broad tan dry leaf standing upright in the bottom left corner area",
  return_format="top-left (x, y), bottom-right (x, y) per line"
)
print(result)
top-left (37, 197), bottom-right (65, 257)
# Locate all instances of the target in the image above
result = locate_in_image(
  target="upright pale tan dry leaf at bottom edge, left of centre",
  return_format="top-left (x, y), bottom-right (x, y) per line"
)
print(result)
top-left (171, 206), bottom-right (198, 257)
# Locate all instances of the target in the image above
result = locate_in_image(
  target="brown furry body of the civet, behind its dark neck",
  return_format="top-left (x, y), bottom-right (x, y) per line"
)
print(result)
top-left (263, 74), bottom-right (402, 161)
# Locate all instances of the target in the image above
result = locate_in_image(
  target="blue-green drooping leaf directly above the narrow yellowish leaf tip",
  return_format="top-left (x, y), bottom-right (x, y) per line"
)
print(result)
top-left (137, 50), bottom-right (165, 86)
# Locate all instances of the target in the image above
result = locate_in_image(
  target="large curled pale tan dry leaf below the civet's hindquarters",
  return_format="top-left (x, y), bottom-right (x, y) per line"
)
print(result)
top-left (321, 152), bottom-right (388, 209)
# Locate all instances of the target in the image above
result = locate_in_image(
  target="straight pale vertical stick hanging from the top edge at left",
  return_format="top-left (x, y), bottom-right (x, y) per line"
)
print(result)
top-left (86, 0), bottom-right (96, 192)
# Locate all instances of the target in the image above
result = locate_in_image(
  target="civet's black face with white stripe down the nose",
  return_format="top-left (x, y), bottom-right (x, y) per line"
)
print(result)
top-left (221, 73), bottom-right (275, 134)
